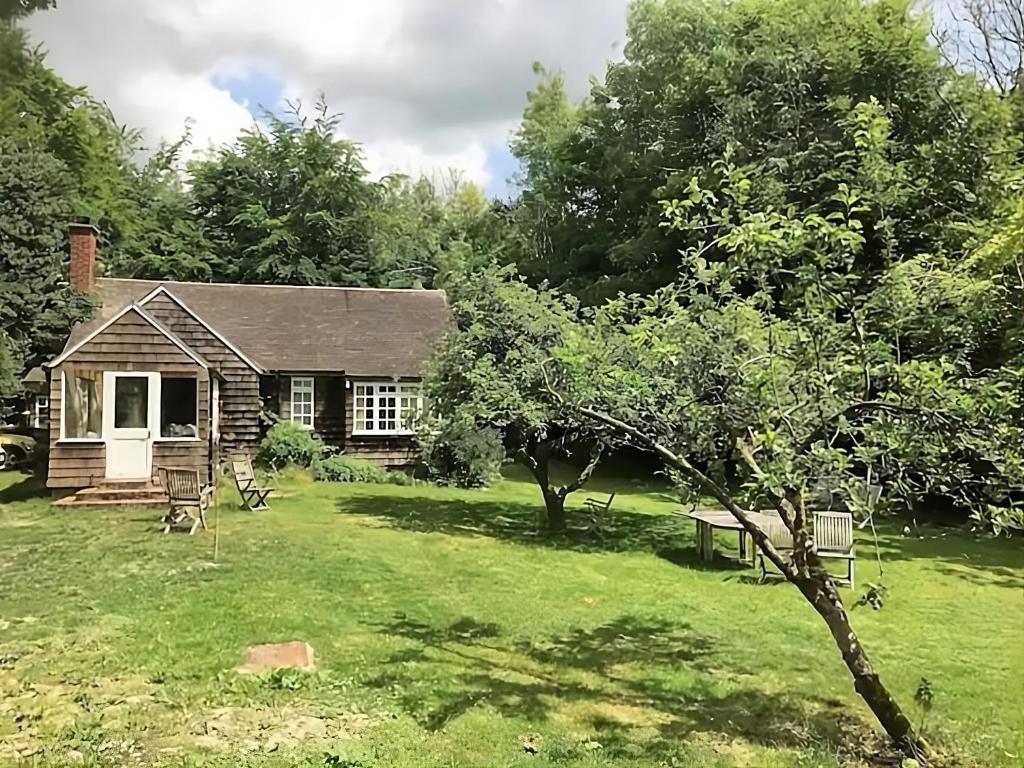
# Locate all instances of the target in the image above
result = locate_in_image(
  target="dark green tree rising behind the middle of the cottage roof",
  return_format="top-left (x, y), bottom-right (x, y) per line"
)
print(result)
top-left (188, 100), bottom-right (382, 286)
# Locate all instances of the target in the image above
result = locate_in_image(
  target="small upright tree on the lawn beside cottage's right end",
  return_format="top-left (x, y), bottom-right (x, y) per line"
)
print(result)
top-left (424, 267), bottom-right (603, 531)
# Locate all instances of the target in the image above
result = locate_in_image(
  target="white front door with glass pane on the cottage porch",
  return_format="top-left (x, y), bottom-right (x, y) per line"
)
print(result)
top-left (103, 372), bottom-right (160, 479)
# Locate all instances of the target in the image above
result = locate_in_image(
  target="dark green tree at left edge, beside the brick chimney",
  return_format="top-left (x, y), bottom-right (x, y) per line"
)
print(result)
top-left (0, 139), bottom-right (91, 368)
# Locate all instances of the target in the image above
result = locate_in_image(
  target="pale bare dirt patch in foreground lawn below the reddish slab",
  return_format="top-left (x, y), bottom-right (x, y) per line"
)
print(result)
top-left (190, 706), bottom-right (373, 752)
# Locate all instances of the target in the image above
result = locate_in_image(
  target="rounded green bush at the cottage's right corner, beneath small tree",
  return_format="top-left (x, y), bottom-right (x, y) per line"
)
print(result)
top-left (420, 420), bottom-right (505, 488)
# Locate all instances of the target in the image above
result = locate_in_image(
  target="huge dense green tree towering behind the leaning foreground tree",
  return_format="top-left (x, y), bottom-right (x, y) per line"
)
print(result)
top-left (513, 0), bottom-right (1018, 304)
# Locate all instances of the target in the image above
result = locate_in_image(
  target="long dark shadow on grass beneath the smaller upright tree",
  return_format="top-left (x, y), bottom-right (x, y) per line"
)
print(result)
top-left (338, 496), bottom-right (697, 567)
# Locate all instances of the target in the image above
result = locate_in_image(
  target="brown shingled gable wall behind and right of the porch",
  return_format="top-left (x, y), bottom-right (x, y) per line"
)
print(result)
top-left (145, 293), bottom-right (262, 457)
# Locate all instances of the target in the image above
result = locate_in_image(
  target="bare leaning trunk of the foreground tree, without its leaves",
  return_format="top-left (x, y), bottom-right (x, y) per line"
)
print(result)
top-left (580, 408), bottom-right (928, 762)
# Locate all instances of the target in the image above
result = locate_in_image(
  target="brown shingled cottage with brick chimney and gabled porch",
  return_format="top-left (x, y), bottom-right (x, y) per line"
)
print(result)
top-left (45, 224), bottom-right (449, 499)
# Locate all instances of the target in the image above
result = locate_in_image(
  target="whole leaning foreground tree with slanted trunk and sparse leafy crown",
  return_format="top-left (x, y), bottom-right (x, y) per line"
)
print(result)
top-left (536, 123), bottom-right (1024, 756)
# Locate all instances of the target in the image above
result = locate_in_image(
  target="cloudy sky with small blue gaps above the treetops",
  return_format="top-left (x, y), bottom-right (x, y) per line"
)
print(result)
top-left (27, 0), bottom-right (627, 197)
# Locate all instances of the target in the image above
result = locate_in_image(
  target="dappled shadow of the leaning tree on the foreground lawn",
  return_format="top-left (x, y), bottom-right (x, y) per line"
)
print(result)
top-left (370, 614), bottom-right (866, 760)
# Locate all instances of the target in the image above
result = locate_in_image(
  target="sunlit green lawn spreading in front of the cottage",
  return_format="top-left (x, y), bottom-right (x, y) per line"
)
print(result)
top-left (0, 474), bottom-right (1024, 768)
